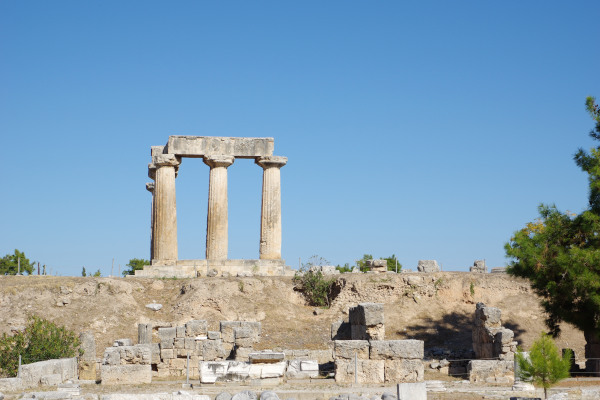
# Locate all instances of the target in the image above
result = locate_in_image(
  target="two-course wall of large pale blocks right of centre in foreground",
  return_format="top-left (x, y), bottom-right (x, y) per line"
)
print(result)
top-left (334, 340), bottom-right (424, 383)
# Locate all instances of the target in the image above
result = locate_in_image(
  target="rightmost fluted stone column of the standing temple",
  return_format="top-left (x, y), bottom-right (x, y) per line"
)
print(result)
top-left (256, 156), bottom-right (287, 260)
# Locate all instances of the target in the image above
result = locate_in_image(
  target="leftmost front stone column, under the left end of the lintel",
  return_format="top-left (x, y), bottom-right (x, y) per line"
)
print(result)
top-left (151, 154), bottom-right (180, 265)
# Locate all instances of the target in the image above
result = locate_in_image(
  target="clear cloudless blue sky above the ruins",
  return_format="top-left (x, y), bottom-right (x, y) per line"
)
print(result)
top-left (0, 0), bottom-right (600, 275)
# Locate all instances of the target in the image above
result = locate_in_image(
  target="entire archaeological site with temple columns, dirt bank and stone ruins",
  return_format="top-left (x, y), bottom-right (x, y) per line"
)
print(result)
top-left (0, 136), bottom-right (600, 400)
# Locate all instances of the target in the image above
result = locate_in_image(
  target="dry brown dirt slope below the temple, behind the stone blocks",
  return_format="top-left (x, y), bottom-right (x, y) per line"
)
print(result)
top-left (0, 272), bottom-right (584, 357)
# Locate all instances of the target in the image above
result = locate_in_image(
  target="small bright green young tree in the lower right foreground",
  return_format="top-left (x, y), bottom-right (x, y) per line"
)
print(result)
top-left (516, 334), bottom-right (572, 398)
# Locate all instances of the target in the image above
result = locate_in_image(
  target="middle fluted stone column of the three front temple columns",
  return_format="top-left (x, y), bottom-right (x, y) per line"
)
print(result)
top-left (204, 156), bottom-right (234, 260)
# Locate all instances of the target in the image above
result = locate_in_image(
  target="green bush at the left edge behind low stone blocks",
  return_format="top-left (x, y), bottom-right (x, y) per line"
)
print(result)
top-left (0, 316), bottom-right (81, 377)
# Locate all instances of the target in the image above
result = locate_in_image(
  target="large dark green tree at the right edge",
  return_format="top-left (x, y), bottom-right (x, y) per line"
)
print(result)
top-left (505, 97), bottom-right (600, 336)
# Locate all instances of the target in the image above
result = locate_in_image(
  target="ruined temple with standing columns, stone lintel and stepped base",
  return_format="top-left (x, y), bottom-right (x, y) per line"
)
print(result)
top-left (136, 136), bottom-right (289, 277)
